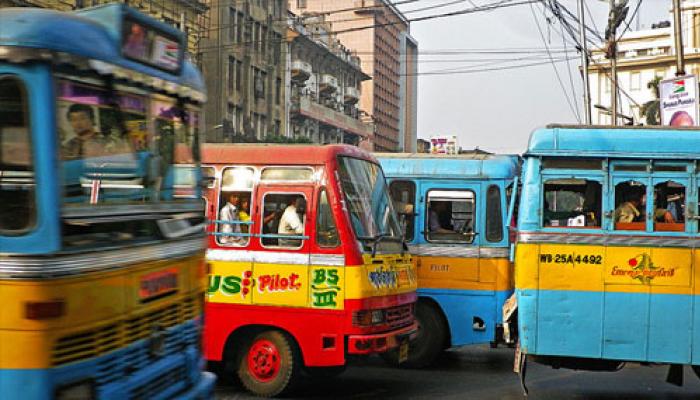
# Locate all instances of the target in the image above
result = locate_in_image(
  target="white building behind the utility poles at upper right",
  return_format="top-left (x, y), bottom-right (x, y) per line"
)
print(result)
top-left (588, 0), bottom-right (700, 124)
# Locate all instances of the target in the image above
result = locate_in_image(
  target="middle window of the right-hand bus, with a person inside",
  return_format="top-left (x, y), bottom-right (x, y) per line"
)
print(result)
top-left (615, 181), bottom-right (647, 231)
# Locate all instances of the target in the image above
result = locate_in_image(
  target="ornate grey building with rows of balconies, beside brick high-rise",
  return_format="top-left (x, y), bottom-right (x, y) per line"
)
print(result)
top-left (287, 13), bottom-right (373, 146)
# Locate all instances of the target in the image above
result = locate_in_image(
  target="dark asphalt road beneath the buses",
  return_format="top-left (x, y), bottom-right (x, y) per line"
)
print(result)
top-left (216, 346), bottom-right (700, 400)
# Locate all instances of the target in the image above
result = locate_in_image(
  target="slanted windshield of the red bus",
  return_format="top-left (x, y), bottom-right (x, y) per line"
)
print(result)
top-left (338, 157), bottom-right (401, 244)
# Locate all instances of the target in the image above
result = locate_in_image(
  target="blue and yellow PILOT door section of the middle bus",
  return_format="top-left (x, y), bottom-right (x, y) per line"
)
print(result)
top-left (418, 182), bottom-right (495, 345)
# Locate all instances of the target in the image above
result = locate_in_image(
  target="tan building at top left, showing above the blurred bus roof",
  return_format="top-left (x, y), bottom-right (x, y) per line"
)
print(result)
top-left (0, 0), bottom-right (210, 57)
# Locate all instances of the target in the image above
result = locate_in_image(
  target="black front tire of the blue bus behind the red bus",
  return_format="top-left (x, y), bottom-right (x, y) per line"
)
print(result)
top-left (383, 302), bottom-right (447, 368)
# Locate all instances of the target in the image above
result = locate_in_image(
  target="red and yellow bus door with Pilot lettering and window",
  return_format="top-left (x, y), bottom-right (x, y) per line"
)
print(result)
top-left (252, 181), bottom-right (315, 307)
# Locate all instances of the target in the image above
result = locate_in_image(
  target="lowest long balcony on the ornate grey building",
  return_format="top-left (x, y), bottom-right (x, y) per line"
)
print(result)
top-left (290, 96), bottom-right (373, 138)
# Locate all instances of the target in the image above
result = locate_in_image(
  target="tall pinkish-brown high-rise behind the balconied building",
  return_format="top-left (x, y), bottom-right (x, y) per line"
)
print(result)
top-left (289, 0), bottom-right (418, 151)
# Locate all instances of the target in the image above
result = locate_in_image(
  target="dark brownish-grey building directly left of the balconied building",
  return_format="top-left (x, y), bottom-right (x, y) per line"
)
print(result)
top-left (201, 0), bottom-right (287, 142)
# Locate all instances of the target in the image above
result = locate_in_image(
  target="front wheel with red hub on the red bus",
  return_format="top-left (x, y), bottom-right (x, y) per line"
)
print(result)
top-left (238, 331), bottom-right (300, 397)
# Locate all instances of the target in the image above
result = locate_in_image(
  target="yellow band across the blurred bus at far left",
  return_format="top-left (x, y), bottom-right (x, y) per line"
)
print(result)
top-left (0, 252), bottom-right (206, 369)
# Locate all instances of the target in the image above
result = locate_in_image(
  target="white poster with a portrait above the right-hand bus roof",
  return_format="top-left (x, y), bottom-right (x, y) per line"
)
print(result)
top-left (659, 75), bottom-right (698, 126)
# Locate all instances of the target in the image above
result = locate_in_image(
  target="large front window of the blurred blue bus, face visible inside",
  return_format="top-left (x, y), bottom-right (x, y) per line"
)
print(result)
top-left (57, 79), bottom-right (199, 207)
